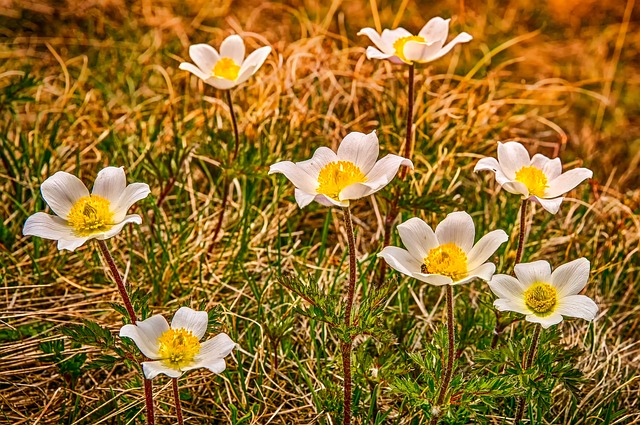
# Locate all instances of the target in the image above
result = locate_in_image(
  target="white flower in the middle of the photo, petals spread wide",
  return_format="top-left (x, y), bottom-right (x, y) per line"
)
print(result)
top-left (269, 131), bottom-right (413, 208)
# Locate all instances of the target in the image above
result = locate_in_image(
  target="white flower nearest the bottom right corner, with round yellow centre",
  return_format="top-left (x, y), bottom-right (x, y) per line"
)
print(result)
top-left (489, 258), bottom-right (598, 329)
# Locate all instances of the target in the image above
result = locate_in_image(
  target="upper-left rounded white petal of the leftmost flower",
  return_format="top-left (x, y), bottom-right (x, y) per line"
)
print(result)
top-left (40, 171), bottom-right (89, 219)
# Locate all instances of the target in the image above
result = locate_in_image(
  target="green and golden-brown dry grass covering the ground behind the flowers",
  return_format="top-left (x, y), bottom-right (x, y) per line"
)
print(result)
top-left (0, 0), bottom-right (640, 425)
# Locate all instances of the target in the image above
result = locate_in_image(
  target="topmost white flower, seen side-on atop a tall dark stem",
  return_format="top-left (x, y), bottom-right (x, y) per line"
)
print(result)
top-left (358, 17), bottom-right (473, 65)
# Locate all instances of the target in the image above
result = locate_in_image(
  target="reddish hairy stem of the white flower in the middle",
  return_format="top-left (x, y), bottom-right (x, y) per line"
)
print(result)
top-left (340, 207), bottom-right (356, 425)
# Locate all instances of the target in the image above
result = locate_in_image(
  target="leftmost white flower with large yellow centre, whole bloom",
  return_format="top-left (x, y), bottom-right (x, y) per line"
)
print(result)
top-left (22, 167), bottom-right (150, 251)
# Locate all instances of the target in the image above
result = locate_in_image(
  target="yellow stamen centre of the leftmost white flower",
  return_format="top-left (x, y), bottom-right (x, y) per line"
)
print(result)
top-left (67, 195), bottom-right (114, 237)
